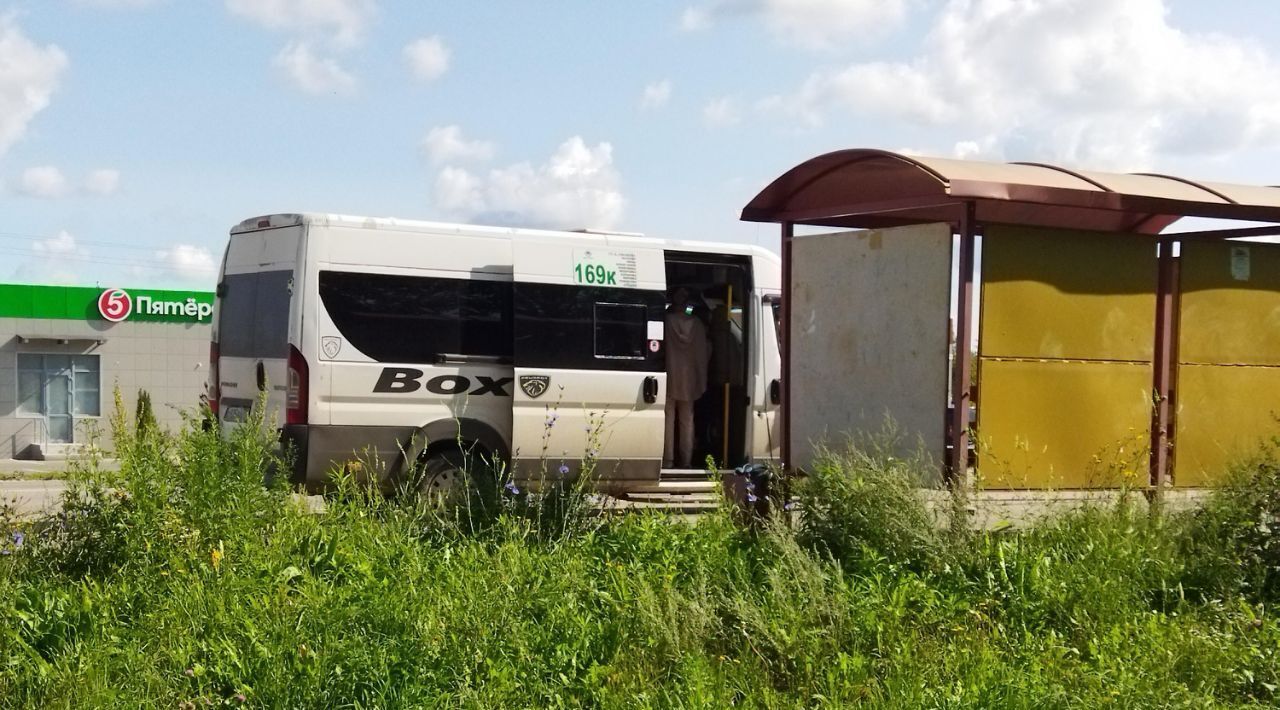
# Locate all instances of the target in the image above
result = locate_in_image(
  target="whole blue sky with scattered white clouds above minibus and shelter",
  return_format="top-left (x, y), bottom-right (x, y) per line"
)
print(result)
top-left (0, 0), bottom-right (1280, 288)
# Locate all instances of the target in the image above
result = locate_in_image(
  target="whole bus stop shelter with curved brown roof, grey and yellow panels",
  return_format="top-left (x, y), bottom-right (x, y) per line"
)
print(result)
top-left (742, 150), bottom-right (1280, 489)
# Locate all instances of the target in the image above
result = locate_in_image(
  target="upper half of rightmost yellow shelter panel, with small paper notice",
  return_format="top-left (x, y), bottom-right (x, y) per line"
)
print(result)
top-left (1178, 242), bottom-right (1280, 365)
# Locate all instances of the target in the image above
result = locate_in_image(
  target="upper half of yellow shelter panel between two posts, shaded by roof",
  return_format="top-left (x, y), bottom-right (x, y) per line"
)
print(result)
top-left (979, 225), bottom-right (1156, 362)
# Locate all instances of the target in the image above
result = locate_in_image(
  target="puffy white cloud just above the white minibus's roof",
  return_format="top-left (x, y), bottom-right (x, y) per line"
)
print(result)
top-left (434, 136), bottom-right (626, 229)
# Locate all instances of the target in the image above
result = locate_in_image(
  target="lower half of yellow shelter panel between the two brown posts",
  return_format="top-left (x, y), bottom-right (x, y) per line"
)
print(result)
top-left (977, 358), bottom-right (1152, 489)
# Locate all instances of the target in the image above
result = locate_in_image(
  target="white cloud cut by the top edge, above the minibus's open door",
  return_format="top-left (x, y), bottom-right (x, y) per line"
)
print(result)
top-left (680, 0), bottom-right (908, 50)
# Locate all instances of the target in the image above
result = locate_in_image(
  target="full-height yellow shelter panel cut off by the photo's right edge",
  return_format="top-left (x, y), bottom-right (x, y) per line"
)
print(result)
top-left (1174, 242), bottom-right (1280, 486)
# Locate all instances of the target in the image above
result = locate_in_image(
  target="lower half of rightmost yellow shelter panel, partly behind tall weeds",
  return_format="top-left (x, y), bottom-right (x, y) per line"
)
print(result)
top-left (1174, 365), bottom-right (1280, 487)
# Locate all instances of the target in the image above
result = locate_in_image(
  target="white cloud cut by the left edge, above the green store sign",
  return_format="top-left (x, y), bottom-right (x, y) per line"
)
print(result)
top-left (0, 13), bottom-right (67, 161)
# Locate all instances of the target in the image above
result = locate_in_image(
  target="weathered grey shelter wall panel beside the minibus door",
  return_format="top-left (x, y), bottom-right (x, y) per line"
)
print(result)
top-left (788, 224), bottom-right (952, 475)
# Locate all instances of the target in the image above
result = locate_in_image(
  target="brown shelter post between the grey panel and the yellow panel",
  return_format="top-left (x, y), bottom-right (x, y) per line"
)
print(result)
top-left (947, 202), bottom-right (978, 485)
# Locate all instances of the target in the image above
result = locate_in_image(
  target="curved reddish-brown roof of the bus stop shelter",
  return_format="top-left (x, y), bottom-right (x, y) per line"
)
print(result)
top-left (742, 148), bottom-right (1280, 234)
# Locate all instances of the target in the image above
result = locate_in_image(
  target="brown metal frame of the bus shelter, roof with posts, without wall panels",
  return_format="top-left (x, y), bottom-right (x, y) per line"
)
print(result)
top-left (741, 148), bottom-right (1280, 486)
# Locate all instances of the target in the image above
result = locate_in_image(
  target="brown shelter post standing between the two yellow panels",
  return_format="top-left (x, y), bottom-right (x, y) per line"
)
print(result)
top-left (1151, 239), bottom-right (1179, 490)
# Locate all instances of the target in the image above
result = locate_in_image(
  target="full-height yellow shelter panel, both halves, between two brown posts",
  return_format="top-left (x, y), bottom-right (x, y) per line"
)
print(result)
top-left (977, 225), bottom-right (1157, 489)
